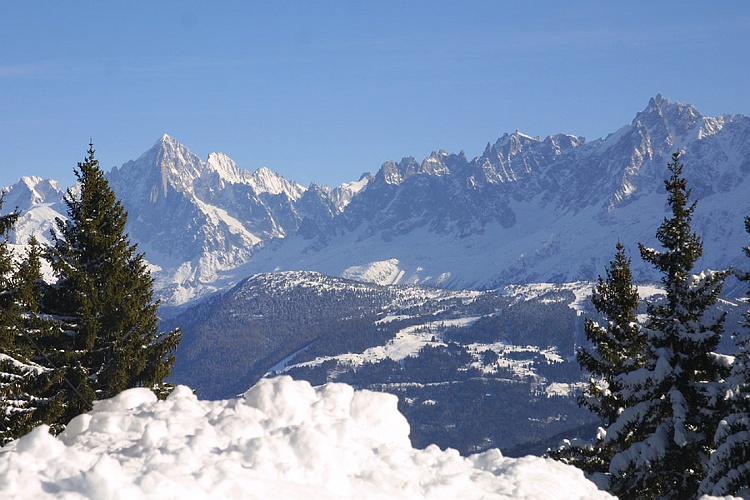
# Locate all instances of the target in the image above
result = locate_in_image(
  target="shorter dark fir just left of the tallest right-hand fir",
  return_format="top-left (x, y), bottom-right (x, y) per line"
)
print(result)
top-left (550, 242), bottom-right (647, 473)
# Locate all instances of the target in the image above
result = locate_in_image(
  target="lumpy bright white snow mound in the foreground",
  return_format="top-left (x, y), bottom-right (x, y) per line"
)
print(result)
top-left (0, 376), bottom-right (609, 500)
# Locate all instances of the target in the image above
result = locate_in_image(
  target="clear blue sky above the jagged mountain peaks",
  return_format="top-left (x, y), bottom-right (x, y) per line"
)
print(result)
top-left (0, 0), bottom-right (750, 187)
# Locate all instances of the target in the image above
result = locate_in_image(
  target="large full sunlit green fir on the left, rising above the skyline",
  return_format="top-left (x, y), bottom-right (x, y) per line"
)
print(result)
top-left (46, 145), bottom-right (180, 421)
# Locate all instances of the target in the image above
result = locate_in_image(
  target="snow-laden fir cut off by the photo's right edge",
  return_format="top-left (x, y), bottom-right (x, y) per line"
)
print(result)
top-left (701, 217), bottom-right (750, 496)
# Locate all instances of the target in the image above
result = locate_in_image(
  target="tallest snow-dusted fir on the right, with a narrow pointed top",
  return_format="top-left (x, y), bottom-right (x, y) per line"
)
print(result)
top-left (606, 153), bottom-right (728, 499)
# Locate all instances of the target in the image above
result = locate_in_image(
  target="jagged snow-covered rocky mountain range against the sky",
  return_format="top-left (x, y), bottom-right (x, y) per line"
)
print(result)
top-left (5, 95), bottom-right (750, 305)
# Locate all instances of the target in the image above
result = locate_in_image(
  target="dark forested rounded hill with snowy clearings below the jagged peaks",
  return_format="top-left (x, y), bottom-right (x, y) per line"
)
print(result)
top-left (165, 271), bottom-right (591, 453)
